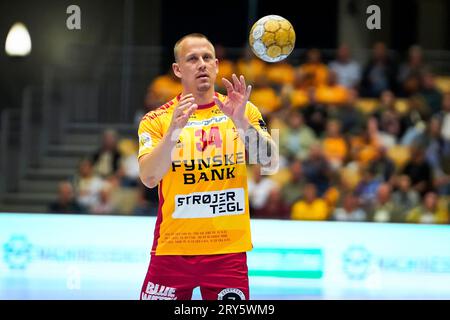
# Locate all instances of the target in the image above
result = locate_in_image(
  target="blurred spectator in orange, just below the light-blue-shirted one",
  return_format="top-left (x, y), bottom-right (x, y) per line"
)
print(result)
top-left (315, 70), bottom-right (349, 106)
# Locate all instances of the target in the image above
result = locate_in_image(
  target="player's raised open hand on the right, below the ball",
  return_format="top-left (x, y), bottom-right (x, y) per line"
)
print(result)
top-left (214, 73), bottom-right (252, 125)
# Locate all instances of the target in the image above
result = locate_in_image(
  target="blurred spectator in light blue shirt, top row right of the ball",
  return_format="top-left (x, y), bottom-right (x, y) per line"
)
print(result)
top-left (328, 43), bottom-right (361, 89)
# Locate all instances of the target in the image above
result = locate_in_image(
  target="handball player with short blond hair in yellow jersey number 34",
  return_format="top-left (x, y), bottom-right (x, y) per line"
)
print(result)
top-left (138, 33), bottom-right (277, 300)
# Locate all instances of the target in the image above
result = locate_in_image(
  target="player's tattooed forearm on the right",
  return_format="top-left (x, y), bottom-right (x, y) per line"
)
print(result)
top-left (235, 120), bottom-right (279, 174)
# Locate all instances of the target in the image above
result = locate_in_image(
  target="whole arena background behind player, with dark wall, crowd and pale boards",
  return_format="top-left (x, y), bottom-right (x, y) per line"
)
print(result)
top-left (0, 0), bottom-right (450, 299)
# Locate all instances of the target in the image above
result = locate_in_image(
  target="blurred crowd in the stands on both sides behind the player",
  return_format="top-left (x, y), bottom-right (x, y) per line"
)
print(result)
top-left (50, 42), bottom-right (450, 223)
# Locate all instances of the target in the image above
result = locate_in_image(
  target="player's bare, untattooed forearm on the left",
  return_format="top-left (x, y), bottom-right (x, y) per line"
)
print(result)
top-left (139, 133), bottom-right (177, 188)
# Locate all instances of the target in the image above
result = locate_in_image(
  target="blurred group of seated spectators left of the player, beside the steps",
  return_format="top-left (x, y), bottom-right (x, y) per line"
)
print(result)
top-left (49, 130), bottom-right (158, 215)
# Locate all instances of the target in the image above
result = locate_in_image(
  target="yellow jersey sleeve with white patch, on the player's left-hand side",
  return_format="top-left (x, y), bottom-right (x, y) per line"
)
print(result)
top-left (138, 115), bottom-right (163, 159)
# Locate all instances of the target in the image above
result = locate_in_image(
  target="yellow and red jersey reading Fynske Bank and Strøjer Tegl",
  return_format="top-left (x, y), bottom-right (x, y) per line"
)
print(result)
top-left (138, 93), bottom-right (269, 255)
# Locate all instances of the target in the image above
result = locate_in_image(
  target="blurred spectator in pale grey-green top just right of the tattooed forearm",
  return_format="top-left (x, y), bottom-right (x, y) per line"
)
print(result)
top-left (280, 110), bottom-right (317, 160)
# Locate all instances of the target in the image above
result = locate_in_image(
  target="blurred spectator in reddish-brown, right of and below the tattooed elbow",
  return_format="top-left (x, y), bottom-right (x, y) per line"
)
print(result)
top-left (281, 159), bottom-right (306, 208)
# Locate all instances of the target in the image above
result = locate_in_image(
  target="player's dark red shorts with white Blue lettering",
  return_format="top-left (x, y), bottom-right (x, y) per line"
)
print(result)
top-left (140, 252), bottom-right (249, 300)
